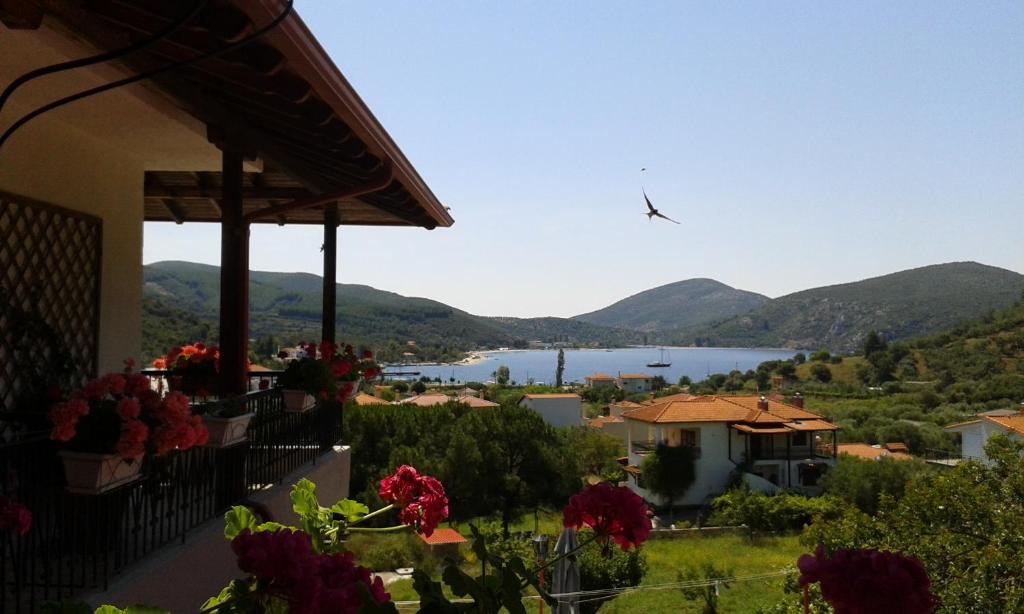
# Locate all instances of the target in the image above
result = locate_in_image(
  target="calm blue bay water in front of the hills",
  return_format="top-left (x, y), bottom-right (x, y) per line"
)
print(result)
top-left (387, 348), bottom-right (796, 384)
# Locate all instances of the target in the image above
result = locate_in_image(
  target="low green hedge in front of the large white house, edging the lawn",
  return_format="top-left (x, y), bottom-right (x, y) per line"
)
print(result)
top-left (709, 487), bottom-right (849, 533)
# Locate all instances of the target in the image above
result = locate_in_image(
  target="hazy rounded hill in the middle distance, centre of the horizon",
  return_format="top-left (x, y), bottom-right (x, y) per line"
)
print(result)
top-left (573, 278), bottom-right (769, 333)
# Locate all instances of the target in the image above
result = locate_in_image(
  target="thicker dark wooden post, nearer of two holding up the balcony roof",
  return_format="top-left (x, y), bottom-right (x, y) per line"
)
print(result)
top-left (220, 148), bottom-right (249, 395)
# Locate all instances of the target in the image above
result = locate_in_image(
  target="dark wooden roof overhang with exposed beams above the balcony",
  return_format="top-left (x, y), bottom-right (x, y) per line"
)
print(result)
top-left (29, 0), bottom-right (454, 228)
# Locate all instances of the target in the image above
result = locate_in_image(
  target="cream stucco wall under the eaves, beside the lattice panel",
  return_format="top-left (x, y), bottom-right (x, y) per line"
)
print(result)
top-left (0, 24), bottom-right (220, 372)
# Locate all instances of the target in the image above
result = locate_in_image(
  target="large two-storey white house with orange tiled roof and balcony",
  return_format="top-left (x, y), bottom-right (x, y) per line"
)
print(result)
top-left (622, 396), bottom-right (839, 506)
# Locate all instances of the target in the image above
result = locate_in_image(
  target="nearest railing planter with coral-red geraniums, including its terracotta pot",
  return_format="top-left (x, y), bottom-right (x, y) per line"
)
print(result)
top-left (47, 361), bottom-right (207, 494)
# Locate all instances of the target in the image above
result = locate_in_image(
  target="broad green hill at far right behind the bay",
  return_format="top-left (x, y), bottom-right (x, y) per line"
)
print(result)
top-left (674, 262), bottom-right (1024, 352)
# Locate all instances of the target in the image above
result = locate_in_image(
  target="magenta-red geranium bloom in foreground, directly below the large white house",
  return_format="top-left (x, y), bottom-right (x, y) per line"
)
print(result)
top-left (562, 483), bottom-right (650, 550)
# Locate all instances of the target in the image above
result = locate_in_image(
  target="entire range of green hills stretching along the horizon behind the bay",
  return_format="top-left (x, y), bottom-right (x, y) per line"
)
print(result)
top-left (143, 261), bottom-right (1024, 360)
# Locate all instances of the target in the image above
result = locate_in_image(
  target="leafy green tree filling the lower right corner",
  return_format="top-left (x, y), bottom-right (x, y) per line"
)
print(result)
top-left (804, 437), bottom-right (1024, 614)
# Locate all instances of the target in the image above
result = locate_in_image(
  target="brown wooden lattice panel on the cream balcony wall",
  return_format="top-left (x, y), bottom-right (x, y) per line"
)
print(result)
top-left (0, 192), bottom-right (102, 411)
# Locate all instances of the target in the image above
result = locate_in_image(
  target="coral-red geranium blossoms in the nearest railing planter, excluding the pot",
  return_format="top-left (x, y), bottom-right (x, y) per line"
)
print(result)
top-left (48, 360), bottom-right (207, 459)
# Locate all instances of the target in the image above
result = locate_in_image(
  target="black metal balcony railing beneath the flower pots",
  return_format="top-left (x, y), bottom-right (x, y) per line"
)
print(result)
top-left (0, 389), bottom-right (341, 613)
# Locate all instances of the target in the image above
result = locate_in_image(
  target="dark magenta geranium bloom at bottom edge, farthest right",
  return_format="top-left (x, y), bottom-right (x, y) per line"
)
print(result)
top-left (797, 545), bottom-right (937, 614)
